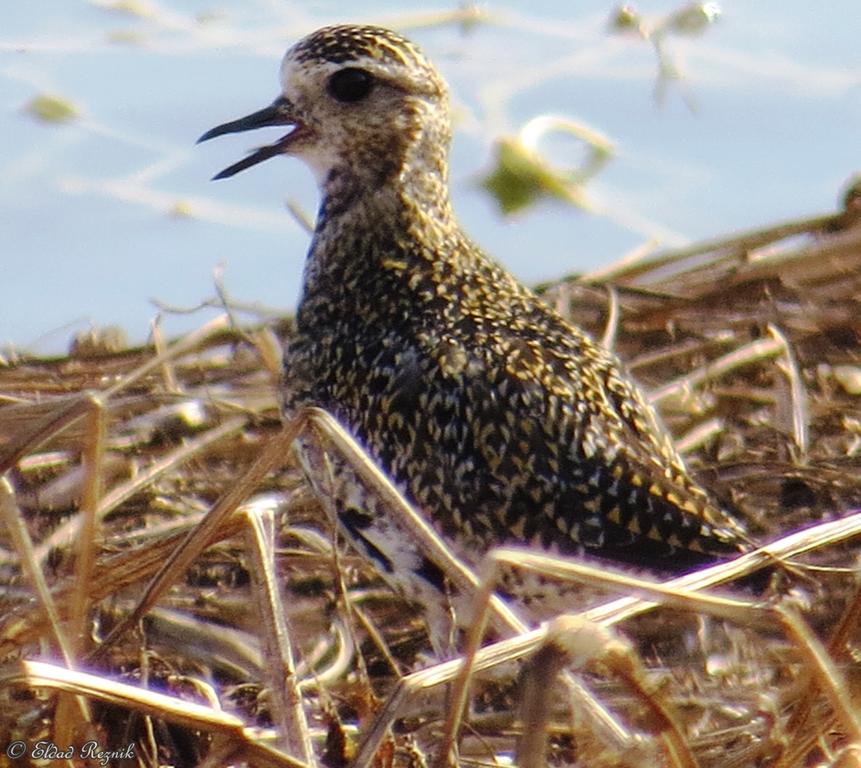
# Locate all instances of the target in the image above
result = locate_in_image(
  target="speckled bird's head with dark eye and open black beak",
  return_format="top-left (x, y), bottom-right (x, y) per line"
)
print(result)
top-left (200, 25), bottom-right (450, 190)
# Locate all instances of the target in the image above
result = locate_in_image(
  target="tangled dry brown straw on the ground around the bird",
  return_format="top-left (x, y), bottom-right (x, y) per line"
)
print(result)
top-left (0, 188), bottom-right (861, 768)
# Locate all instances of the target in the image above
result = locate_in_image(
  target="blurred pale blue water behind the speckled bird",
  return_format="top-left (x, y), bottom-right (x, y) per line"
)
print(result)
top-left (5, 0), bottom-right (861, 357)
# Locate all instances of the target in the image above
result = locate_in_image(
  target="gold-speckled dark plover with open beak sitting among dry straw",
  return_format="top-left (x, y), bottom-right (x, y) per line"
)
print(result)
top-left (199, 24), bottom-right (748, 616)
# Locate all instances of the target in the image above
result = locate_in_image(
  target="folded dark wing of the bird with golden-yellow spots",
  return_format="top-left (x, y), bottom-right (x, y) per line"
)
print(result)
top-left (456, 307), bottom-right (740, 554)
